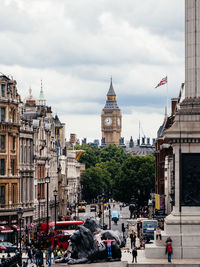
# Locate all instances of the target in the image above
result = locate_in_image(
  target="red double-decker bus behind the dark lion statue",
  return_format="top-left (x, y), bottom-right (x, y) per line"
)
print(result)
top-left (39, 221), bottom-right (84, 250)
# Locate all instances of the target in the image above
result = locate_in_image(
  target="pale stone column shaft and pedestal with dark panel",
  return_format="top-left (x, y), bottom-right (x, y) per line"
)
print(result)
top-left (145, 0), bottom-right (200, 259)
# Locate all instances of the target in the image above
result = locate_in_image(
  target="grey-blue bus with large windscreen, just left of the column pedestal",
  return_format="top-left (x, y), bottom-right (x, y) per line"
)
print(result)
top-left (137, 218), bottom-right (158, 241)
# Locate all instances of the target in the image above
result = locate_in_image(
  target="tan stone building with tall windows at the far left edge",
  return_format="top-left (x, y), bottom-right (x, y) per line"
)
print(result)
top-left (0, 75), bottom-right (20, 241)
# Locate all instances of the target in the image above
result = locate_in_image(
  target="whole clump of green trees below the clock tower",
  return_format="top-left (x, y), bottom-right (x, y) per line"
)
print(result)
top-left (75, 145), bottom-right (155, 203)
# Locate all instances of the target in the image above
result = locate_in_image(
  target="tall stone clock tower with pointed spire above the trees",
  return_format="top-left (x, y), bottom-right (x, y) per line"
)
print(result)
top-left (101, 78), bottom-right (122, 146)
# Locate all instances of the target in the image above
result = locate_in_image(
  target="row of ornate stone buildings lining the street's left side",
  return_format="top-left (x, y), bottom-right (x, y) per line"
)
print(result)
top-left (0, 75), bottom-right (83, 242)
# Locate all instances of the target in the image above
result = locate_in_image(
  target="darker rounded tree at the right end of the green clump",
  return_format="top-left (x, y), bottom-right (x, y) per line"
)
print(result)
top-left (113, 156), bottom-right (155, 205)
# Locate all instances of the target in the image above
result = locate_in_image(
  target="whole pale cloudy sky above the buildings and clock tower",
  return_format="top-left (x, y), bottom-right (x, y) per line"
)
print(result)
top-left (0, 0), bottom-right (185, 144)
